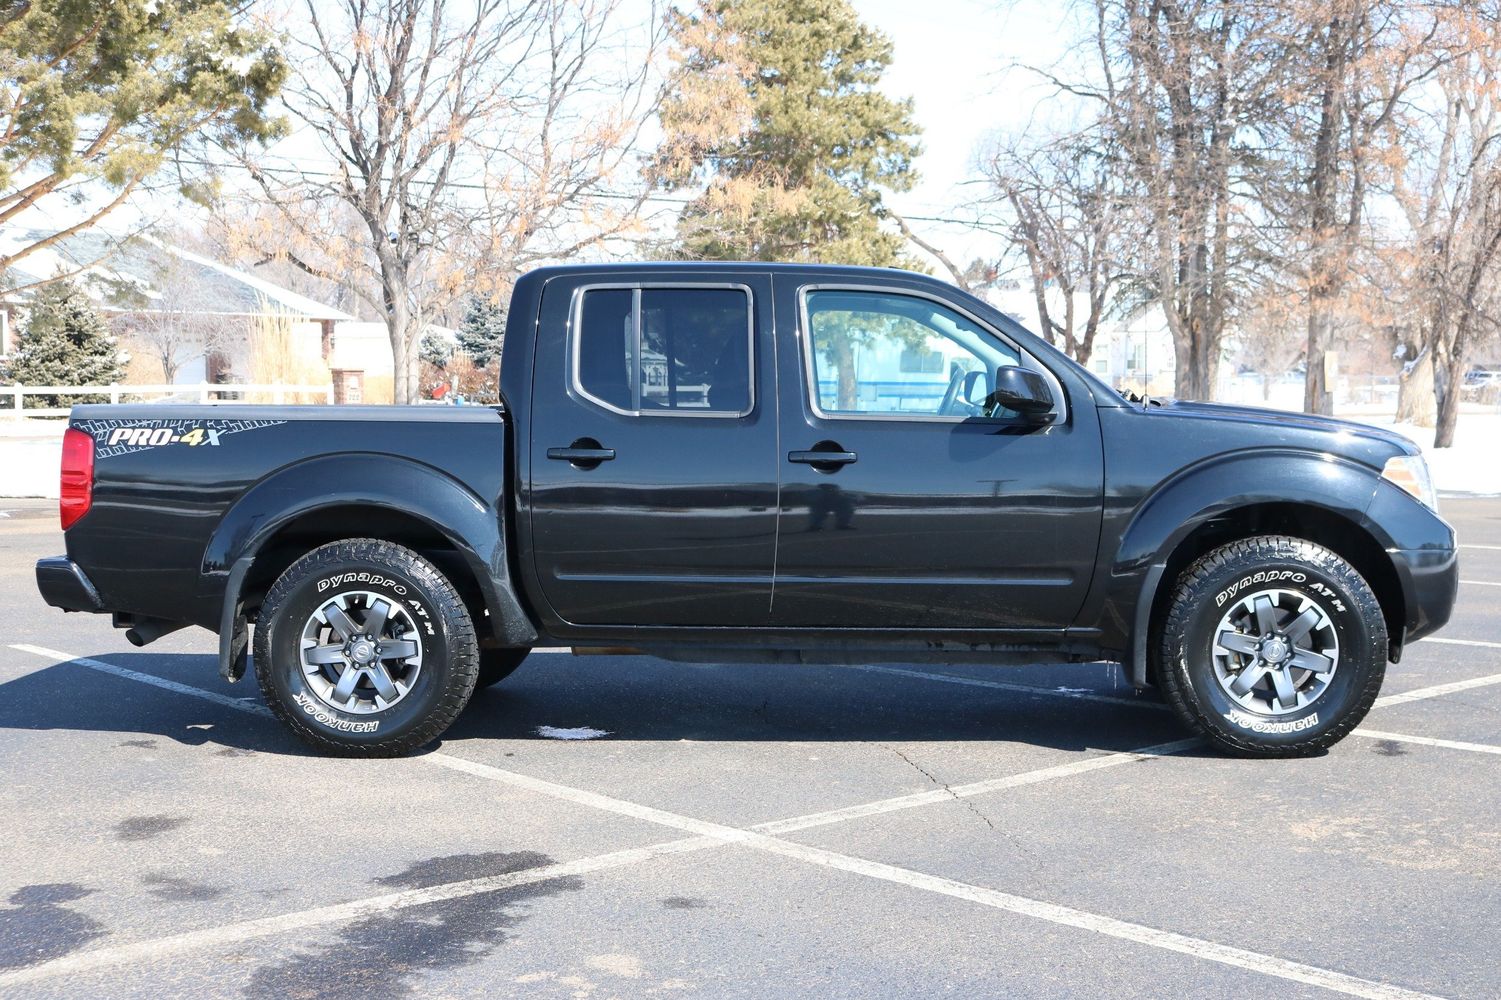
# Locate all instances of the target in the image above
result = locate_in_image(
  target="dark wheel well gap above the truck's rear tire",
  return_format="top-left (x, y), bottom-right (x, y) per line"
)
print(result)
top-left (240, 505), bottom-right (489, 633)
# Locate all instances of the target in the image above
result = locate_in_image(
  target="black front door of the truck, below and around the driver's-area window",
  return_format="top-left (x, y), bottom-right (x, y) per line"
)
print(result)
top-left (772, 273), bottom-right (1103, 631)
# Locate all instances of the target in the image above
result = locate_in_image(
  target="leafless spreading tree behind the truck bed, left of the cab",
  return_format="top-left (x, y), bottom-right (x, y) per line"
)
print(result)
top-left (232, 0), bottom-right (656, 402)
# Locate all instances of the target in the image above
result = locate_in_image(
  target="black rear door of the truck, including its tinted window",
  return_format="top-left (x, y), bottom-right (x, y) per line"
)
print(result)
top-left (530, 270), bottom-right (778, 626)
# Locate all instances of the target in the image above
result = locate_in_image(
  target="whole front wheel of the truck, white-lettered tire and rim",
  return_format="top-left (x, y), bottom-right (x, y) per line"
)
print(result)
top-left (1157, 536), bottom-right (1387, 757)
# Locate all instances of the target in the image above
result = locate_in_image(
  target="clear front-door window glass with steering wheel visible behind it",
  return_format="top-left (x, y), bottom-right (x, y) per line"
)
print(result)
top-left (805, 290), bottom-right (1021, 419)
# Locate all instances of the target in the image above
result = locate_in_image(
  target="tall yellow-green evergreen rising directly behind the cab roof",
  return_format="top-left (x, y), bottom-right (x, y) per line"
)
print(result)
top-left (657, 0), bottom-right (919, 266)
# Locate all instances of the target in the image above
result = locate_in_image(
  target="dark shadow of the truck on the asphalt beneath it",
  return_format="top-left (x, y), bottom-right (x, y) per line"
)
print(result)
top-left (0, 653), bottom-right (1184, 757)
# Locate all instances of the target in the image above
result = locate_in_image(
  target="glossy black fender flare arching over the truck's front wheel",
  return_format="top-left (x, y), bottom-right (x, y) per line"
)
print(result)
top-left (1106, 449), bottom-right (1390, 686)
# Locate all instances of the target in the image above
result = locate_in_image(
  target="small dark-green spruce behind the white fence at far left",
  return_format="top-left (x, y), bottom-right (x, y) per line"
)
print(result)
top-left (6, 281), bottom-right (125, 407)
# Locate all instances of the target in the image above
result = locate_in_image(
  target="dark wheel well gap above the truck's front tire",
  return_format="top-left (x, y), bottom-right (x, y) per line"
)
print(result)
top-left (1148, 503), bottom-right (1406, 672)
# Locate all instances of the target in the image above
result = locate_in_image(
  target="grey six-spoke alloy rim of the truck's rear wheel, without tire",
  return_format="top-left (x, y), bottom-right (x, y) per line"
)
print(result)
top-left (302, 590), bottom-right (422, 715)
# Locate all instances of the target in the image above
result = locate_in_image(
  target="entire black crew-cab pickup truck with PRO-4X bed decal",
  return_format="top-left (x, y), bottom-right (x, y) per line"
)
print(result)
top-left (36, 263), bottom-right (1457, 757)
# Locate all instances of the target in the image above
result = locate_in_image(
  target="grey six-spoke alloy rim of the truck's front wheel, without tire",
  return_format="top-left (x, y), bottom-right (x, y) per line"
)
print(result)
top-left (1211, 589), bottom-right (1339, 715)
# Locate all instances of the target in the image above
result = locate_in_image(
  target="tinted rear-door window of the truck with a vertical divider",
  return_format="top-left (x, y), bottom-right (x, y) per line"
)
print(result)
top-left (572, 287), bottom-right (754, 416)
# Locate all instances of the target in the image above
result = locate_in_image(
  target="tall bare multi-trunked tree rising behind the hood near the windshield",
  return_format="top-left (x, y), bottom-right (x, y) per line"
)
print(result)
top-left (1039, 0), bottom-right (1286, 399)
